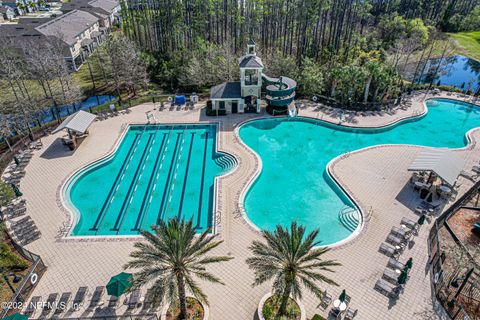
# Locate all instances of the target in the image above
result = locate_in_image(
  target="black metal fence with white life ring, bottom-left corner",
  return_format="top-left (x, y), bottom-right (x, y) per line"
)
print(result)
top-left (0, 241), bottom-right (47, 318)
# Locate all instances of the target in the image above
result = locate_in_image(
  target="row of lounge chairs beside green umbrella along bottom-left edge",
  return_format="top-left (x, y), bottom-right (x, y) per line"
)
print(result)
top-left (24, 286), bottom-right (156, 317)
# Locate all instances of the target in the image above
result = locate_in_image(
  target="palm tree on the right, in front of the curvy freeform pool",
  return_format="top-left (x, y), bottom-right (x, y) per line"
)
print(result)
top-left (247, 222), bottom-right (340, 316)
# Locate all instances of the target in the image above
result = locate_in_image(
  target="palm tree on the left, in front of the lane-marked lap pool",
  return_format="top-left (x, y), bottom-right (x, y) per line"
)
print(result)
top-left (125, 218), bottom-right (233, 319)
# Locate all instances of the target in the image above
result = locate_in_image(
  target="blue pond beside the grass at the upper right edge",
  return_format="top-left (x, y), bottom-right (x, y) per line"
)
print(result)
top-left (416, 55), bottom-right (480, 92)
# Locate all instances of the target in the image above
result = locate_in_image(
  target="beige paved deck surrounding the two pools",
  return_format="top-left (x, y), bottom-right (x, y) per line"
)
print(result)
top-left (14, 94), bottom-right (480, 320)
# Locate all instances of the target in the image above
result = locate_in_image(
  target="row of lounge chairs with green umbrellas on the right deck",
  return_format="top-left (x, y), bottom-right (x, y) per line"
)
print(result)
top-left (375, 217), bottom-right (419, 299)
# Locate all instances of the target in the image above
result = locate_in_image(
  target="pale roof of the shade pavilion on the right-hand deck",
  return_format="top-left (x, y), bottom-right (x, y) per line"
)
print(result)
top-left (408, 149), bottom-right (465, 187)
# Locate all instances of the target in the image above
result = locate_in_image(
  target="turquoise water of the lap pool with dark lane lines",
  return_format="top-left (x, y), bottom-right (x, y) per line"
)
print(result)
top-left (65, 125), bottom-right (236, 236)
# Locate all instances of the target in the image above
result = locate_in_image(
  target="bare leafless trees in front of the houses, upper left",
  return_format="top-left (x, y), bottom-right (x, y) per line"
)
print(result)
top-left (0, 34), bottom-right (148, 143)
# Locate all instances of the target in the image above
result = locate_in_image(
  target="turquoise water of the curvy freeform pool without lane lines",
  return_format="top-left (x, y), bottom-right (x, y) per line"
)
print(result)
top-left (239, 99), bottom-right (480, 245)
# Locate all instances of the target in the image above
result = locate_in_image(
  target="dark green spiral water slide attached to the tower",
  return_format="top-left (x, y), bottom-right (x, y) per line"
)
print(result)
top-left (262, 74), bottom-right (297, 107)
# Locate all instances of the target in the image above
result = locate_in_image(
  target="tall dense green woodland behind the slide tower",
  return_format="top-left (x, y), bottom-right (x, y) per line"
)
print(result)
top-left (122, 0), bottom-right (479, 102)
